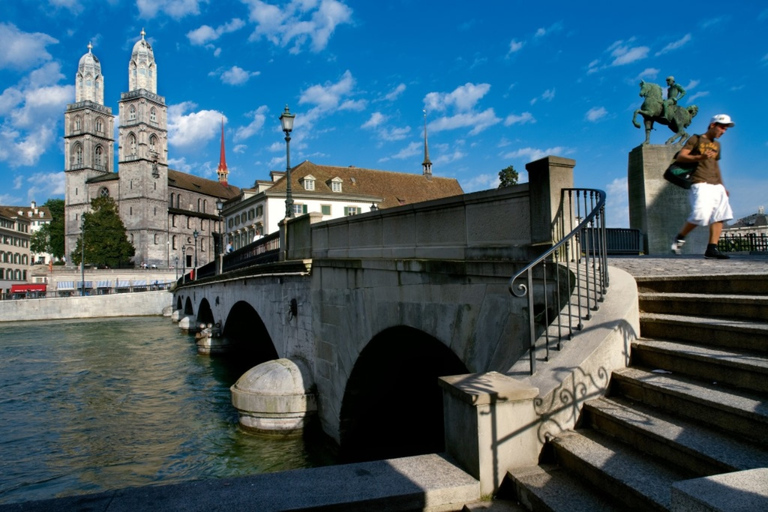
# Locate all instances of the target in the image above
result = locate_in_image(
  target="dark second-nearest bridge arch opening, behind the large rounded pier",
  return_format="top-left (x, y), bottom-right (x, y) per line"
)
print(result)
top-left (224, 300), bottom-right (280, 370)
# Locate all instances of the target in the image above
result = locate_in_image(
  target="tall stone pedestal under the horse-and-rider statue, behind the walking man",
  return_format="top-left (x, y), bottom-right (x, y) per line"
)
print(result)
top-left (627, 144), bottom-right (709, 255)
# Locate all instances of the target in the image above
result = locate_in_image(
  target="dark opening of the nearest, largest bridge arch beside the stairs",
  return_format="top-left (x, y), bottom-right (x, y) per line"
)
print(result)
top-left (339, 326), bottom-right (469, 462)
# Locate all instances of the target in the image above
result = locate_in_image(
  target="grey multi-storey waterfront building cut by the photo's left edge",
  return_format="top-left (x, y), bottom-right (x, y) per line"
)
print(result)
top-left (0, 206), bottom-right (32, 298)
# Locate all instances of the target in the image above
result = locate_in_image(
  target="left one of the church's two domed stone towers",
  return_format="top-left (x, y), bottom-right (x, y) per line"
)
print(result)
top-left (64, 43), bottom-right (114, 261)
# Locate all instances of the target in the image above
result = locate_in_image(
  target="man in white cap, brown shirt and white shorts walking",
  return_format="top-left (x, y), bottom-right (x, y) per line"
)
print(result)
top-left (672, 114), bottom-right (734, 260)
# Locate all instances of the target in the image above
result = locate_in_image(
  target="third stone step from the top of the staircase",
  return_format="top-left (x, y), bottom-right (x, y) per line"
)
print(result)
top-left (640, 313), bottom-right (768, 352)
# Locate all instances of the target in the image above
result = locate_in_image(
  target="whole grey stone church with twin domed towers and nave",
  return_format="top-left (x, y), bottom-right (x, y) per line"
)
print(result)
top-left (64, 31), bottom-right (240, 268)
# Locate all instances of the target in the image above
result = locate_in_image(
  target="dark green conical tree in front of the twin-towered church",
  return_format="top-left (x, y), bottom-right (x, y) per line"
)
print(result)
top-left (72, 197), bottom-right (136, 268)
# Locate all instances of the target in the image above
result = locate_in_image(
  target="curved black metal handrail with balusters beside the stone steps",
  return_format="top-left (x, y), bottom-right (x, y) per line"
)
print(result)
top-left (509, 188), bottom-right (608, 375)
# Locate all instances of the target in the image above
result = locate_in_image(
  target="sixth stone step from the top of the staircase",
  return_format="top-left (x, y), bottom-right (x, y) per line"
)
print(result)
top-left (582, 397), bottom-right (768, 476)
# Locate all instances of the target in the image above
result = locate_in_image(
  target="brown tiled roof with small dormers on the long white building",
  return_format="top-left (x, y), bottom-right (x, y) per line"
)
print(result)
top-left (266, 160), bottom-right (464, 208)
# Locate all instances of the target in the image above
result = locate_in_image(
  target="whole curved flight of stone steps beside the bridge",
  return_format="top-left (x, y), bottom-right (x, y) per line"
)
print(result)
top-left (499, 275), bottom-right (768, 512)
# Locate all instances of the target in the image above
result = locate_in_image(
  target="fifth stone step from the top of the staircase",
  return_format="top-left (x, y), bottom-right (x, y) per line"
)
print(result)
top-left (609, 368), bottom-right (768, 445)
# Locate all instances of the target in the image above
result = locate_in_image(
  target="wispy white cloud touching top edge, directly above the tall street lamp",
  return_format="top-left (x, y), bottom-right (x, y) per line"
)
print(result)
top-left (243, 0), bottom-right (352, 53)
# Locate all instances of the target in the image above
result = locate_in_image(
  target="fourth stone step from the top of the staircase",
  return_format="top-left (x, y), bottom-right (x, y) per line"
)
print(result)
top-left (632, 338), bottom-right (768, 393)
